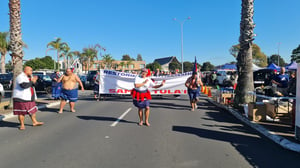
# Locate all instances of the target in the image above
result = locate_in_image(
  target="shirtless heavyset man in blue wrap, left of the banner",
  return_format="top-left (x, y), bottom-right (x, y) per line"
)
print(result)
top-left (58, 68), bottom-right (84, 114)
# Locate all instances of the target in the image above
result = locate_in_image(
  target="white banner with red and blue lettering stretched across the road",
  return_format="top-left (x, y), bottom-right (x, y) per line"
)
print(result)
top-left (99, 70), bottom-right (192, 95)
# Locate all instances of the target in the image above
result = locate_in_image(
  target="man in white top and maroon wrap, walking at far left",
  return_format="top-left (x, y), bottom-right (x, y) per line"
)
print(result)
top-left (13, 66), bottom-right (44, 130)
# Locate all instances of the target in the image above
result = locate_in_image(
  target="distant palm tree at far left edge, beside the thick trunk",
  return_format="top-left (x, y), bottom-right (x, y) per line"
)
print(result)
top-left (0, 32), bottom-right (9, 73)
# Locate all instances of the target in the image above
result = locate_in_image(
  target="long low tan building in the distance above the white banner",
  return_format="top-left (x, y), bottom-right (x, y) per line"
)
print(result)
top-left (83, 60), bottom-right (146, 71)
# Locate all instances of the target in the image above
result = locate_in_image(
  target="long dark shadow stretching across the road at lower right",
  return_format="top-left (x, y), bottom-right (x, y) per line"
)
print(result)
top-left (172, 126), bottom-right (300, 167)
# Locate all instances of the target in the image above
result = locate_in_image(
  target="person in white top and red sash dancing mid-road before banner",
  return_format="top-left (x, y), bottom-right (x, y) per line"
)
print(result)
top-left (131, 68), bottom-right (165, 126)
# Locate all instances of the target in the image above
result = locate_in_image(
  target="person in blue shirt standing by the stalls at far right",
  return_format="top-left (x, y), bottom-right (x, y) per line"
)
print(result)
top-left (272, 67), bottom-right (289, 95)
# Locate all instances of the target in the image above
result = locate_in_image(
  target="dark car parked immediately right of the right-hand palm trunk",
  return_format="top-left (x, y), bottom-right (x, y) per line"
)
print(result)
top-left (253, 69), bottom-right (274, 87)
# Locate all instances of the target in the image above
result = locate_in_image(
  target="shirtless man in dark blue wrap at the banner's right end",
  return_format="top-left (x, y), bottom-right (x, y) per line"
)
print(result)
top-left (185, 71), bottom-right (203, 111)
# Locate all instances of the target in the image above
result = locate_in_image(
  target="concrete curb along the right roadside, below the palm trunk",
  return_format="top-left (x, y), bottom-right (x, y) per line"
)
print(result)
top-left (207, 99), bottom-right (300, 153)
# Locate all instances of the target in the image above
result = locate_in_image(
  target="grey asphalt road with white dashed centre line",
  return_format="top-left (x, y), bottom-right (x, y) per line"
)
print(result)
top-left (0, 95), bottom-right (300, 168)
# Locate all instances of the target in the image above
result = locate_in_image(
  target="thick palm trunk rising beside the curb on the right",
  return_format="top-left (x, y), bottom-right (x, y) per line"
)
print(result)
top-left (234, 0), bottom-right (255, 107)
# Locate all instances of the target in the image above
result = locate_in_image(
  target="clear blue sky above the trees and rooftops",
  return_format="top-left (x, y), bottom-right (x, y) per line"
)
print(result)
top-left (0, 0), bottom-right (300, 65)
